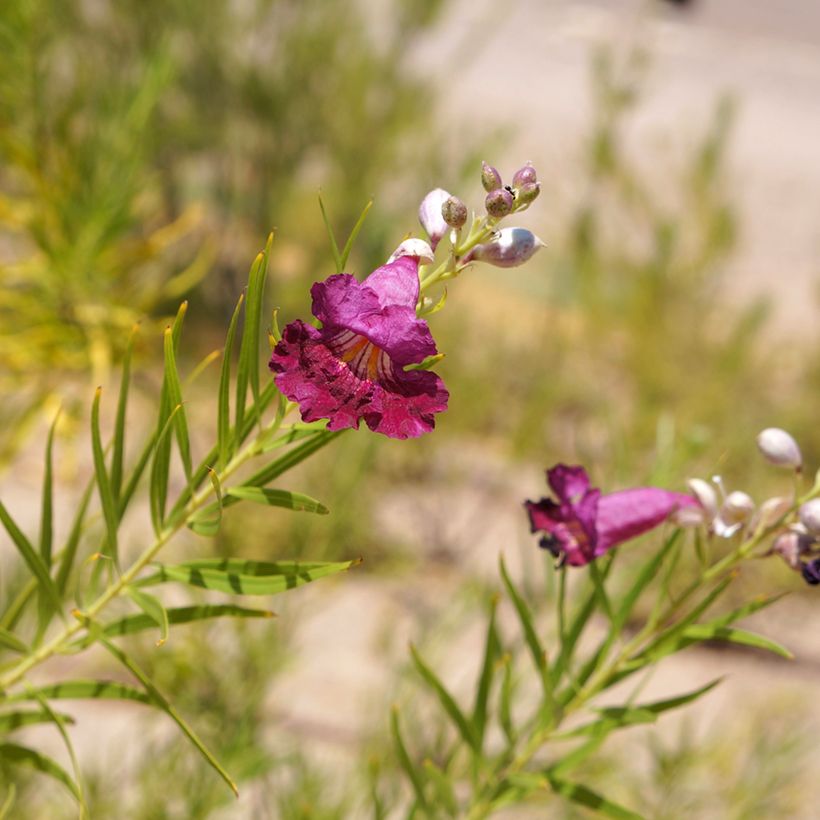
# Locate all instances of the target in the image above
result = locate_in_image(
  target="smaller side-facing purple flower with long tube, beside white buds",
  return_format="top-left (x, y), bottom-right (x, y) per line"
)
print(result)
top-left (524, 464), bottom-right (698, 567)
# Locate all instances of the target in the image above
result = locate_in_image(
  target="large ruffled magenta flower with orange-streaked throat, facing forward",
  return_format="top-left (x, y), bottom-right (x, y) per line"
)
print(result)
top-left (269, 255), bottom-right (449, 439)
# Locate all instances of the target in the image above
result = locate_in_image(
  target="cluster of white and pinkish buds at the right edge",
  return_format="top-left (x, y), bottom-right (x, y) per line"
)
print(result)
top-left (679, 427), bottom-right (820, 585)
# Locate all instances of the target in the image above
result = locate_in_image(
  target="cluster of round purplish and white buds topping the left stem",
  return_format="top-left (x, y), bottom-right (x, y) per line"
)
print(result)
top-left (419, 162), bottom-right (544, 280)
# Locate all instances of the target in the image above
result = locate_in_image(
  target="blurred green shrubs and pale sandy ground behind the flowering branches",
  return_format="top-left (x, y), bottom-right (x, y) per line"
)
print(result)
top-left (0, 0), bottom-right (820, 818)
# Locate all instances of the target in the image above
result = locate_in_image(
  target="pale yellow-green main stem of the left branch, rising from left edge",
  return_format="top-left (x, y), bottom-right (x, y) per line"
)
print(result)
top-left (0, 416), bottom-right (278, 692)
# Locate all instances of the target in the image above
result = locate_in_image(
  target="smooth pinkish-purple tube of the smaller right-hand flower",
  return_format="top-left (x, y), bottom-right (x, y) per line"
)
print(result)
top-left (596, 487), bottom-right (698, 555)
